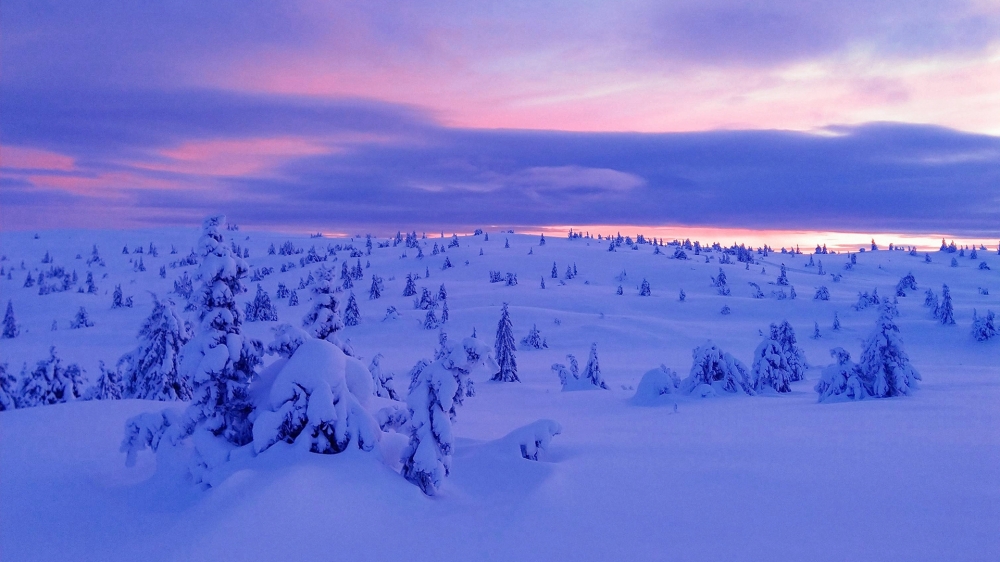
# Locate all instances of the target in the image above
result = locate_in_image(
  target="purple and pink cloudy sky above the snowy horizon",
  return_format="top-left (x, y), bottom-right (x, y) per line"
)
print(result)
top-left (0, 0), bottom-right (1000, 238)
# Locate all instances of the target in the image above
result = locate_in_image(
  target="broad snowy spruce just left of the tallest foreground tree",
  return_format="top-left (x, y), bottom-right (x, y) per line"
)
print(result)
top-left (117, 295), bottom-right (191, 401)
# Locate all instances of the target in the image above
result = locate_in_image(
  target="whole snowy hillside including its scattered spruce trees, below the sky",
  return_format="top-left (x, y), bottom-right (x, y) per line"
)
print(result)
top-left (0, 223), bottom-right (1000, 561)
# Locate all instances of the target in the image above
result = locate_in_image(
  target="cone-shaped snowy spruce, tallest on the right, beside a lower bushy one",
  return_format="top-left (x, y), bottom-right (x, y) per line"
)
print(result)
top-left (858, 302), bottom-right (920, 398)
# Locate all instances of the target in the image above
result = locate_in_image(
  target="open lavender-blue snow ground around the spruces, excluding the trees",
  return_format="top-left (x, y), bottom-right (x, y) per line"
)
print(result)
top-left (0, 225), bottom-right (1000, 561)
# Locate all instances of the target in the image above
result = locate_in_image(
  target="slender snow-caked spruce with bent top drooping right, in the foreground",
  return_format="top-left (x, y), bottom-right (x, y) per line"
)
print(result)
top-left (401, 338), bottom-right (499, 496)
